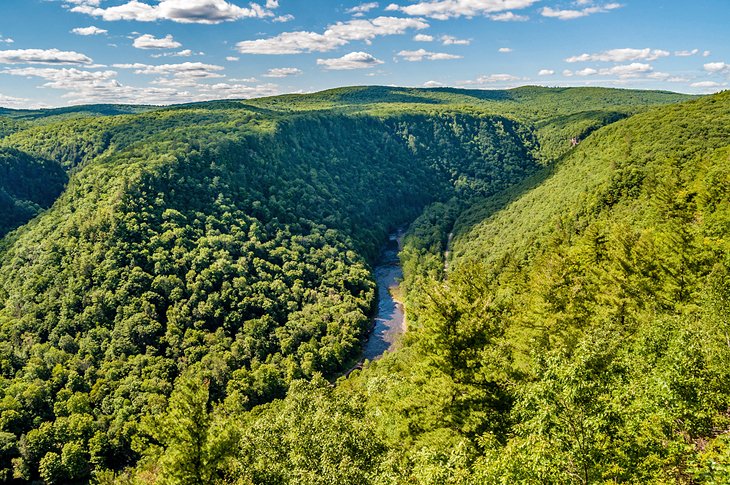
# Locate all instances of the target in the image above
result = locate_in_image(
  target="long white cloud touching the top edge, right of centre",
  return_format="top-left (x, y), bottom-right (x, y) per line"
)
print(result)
top-left (386, 0), bottom-right (538, 20)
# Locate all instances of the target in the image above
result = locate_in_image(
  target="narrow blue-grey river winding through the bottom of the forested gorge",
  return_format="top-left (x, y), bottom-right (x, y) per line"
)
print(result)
top-left (363, 231), bottom-right (406, 360)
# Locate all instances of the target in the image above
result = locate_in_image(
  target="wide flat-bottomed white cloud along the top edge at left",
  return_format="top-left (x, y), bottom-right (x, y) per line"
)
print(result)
top-left (71, 0), bottom-right (273, 24)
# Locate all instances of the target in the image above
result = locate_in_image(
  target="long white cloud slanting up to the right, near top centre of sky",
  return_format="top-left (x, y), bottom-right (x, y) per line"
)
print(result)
top-left (236, 17), bottom-right (429, 54)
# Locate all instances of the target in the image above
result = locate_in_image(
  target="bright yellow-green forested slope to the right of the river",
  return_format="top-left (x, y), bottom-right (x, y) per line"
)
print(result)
top-left (344, 92), bottom-right (730, 483)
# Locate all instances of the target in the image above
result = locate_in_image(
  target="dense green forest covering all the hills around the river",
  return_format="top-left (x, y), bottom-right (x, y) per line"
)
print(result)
top-left (0, 87), bottom-right (730, 484)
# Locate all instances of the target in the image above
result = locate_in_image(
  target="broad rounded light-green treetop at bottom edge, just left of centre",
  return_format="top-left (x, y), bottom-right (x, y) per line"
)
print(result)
top-left (231, 377), bottom-right (385, 484)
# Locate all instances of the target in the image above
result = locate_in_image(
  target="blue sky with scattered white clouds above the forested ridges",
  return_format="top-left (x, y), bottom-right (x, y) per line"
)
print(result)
top-left (0, 0), bottom-right (730, 108)
